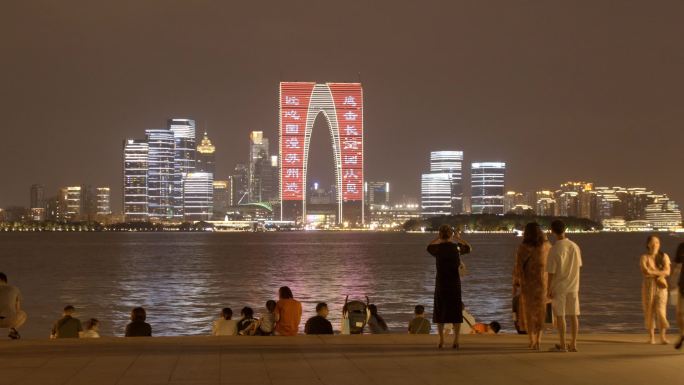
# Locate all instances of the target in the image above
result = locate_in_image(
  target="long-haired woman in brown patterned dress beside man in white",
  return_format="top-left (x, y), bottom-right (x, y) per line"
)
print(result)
top-left (513, 222), bottom-right (551, 350)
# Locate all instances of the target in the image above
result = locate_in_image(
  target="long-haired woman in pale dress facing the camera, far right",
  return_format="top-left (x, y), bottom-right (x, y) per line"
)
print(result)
top-left (640, 235), bottom-right (670, 345)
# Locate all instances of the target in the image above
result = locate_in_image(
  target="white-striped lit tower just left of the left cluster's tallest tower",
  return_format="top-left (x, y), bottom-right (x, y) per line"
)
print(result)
top-left (145, 129), bottom-right (175, 221)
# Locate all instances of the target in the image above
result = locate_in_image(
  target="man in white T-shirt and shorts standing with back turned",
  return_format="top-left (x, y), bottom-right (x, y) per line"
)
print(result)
top-left (546, 220), bottom-right (582, 352)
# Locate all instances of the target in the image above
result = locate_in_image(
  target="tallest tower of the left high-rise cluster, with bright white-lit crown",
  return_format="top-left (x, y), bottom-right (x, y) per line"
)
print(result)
top-left (168, 118), bottom-right (197, 220)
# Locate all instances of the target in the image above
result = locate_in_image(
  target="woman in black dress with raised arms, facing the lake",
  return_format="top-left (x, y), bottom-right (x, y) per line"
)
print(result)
top-left (428, 225), bottom-right (471, 349)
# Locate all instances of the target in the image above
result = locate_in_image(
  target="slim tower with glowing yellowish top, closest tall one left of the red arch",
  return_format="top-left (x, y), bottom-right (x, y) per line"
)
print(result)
top-left (248, 131), bottom-right (271, 202)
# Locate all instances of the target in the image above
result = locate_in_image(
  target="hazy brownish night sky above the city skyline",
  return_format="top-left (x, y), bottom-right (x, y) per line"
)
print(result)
top-left (0, 0), bottom-right (684, 210)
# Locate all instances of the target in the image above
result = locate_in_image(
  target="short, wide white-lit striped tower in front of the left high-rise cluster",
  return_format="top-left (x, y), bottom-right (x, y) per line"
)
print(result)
top-left (183, 172), bottom-right (214, 221)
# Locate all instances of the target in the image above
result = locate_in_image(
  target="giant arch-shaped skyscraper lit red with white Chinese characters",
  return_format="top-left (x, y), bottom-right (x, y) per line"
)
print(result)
top-left (279, 82), bottom-right (364, 226)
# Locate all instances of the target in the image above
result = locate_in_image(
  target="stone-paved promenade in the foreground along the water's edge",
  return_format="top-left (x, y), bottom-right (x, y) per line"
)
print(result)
top-left (0, 334), bottom-right (684, 385)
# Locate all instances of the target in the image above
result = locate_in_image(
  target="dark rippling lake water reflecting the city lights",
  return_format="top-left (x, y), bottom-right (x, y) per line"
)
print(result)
top-left (0, 232), bottom-right (683, 338)
